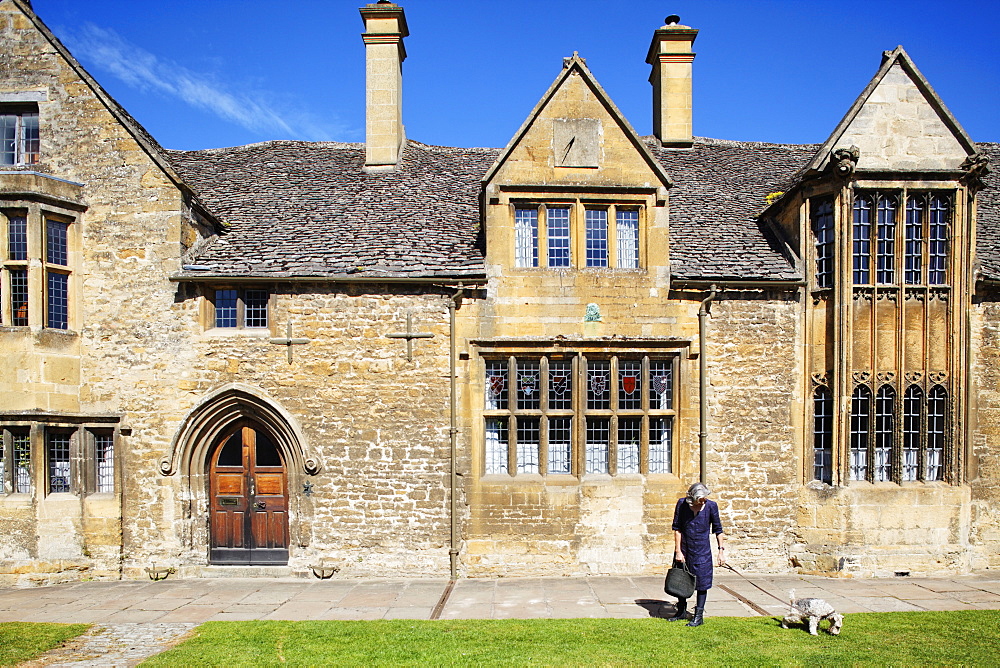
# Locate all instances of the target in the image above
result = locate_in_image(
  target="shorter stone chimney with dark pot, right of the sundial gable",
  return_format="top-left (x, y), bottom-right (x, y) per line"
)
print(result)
top-left (646, 15), bottom-right (698, 148)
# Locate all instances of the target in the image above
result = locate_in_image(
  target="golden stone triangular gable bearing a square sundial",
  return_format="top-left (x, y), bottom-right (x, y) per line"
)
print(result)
top-left (483, 54), bottom-right (670, 188)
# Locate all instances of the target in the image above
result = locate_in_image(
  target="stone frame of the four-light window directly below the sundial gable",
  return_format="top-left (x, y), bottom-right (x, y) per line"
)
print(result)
top-left (510, 197), bottom-right (648, 271)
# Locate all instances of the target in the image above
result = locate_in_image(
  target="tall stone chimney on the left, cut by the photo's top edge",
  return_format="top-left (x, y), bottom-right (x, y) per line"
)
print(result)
top-left (360, 0), bottom-right (410, 171)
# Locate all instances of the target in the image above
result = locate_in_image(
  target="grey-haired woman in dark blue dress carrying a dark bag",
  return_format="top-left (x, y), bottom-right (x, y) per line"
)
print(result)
top-left (667, 482), bottom-right (726, 626)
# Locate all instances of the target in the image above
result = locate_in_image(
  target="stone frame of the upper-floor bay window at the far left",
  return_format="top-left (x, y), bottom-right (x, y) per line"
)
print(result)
top-left (0, 200), bottom-right (80, 333)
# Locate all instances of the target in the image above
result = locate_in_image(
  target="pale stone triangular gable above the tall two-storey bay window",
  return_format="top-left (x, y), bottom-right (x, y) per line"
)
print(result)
top-left (808, 46), bottom-right (977, 176)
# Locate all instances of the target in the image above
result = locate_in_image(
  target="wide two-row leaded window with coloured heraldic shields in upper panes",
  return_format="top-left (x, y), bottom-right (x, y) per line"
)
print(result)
top-left (483, 354), bottom-right (674, 475)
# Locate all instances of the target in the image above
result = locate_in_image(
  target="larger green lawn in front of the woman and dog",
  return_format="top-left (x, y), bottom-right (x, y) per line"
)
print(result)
top-left (142, 610), bottom-right (1000, 667)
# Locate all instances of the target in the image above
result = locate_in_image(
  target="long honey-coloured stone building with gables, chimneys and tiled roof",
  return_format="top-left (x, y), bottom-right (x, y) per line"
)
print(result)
top-left (0, 0), bottom-right (1000, 585)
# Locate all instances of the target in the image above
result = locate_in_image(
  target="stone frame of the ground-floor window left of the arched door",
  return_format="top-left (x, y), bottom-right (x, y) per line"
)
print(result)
top-left (0, 415), bottom-right (124, 499)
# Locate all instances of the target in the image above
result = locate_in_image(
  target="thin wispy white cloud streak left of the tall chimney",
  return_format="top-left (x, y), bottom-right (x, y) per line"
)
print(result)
top-left (61, 23), bottom-right (353, 141)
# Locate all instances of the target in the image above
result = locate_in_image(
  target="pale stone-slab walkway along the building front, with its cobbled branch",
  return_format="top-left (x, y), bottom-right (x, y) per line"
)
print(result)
top-left (0, 570), bottom-right (1000, 666)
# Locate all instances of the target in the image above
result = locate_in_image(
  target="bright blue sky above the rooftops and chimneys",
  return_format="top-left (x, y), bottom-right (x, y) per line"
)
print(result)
top-left (33, 0), bottom-right (1000, 149)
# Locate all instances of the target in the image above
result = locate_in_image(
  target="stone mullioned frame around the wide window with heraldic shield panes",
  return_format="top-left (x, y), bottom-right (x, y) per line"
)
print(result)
top-left (479, 348), bottom-right (681, 478)
